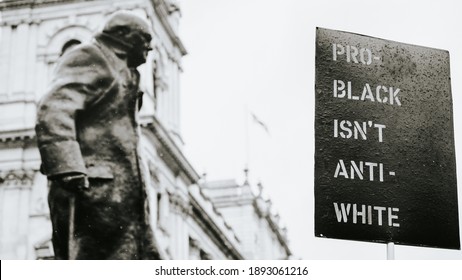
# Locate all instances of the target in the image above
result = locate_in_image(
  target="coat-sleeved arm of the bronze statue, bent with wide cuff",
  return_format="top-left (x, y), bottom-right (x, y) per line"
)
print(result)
top-left (35, 47), bottom-right (114, 177)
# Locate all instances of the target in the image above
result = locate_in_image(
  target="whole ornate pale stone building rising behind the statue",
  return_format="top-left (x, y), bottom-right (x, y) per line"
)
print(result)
top-left (0, 0), bottom-right (290, 259)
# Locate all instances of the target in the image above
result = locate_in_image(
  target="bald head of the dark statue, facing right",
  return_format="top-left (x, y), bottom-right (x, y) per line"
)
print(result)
top-left (103, 11), bottom-right (152, 67)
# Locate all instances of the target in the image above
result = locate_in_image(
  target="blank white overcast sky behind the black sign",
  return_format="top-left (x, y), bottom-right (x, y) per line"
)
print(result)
top-left (181, 0), bottom-right (462, 259)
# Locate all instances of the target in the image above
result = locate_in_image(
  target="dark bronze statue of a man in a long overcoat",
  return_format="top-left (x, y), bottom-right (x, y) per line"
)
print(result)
top-left (36, 11), bottom-right (159, 259)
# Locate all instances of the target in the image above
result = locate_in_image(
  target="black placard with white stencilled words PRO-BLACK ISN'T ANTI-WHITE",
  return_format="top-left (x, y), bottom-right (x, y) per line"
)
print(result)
top-left (315, 28), bottom-right (460, 249)
